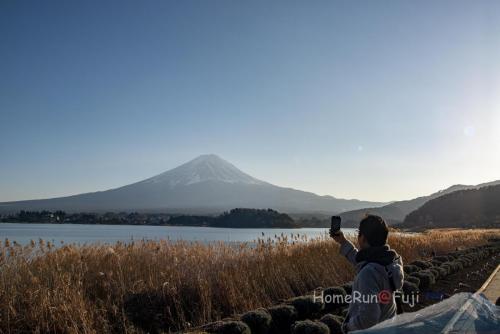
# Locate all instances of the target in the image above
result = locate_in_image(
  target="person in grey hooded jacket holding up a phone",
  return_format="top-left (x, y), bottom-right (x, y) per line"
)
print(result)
top-left (330, 215), bottom-right (404, 333)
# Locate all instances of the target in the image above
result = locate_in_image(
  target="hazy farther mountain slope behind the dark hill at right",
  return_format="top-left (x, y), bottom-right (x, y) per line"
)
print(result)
top-left (340, 180), bottom-right (500, 227)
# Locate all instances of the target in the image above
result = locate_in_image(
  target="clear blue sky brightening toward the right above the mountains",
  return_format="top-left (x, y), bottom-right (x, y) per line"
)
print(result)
top-left (0, 0), bottom-right (500, 201)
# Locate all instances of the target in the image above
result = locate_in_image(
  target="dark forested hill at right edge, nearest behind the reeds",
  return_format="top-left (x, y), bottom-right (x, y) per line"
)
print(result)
top-left (400, 185), bottom-right (500, 228)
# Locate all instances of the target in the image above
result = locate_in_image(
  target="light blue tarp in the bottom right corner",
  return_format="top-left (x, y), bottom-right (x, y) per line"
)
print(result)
top-left (352, 293), bottom-right (500, 334)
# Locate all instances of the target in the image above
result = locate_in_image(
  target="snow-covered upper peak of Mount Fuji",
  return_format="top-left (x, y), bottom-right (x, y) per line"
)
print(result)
top-left (143, 154), bottom-right (265, 187)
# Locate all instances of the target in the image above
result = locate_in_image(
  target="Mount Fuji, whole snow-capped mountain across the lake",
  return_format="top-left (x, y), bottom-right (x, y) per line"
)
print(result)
top-left (0, 154), bottom-right (386, 213)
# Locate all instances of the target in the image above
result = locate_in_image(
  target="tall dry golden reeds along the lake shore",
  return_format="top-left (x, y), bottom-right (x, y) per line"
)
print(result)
top-left (0, 230), bottom-right (500, 333)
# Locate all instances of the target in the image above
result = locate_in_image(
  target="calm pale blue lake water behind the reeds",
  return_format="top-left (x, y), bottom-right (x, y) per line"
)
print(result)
top-left (0, 223), bottom-right (355, 245)
